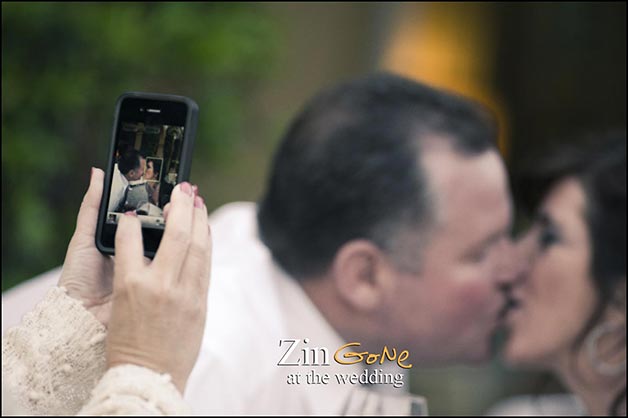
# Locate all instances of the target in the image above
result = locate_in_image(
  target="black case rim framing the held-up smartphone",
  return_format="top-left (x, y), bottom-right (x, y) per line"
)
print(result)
top-left (96, 92), bottom-right (198, 258)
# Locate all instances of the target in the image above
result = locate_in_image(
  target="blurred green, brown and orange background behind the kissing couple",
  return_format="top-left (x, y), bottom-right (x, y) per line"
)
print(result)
top-left (2, 2), bottom-right (626, 415)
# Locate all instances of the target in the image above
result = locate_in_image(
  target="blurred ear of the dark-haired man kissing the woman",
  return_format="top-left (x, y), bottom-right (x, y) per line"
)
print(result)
top-left (331, 240), bottom-right (394, 312)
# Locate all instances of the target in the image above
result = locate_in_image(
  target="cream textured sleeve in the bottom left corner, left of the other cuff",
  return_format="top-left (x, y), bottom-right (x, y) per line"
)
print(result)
top-left (2, 287), bottom-right (106, 415)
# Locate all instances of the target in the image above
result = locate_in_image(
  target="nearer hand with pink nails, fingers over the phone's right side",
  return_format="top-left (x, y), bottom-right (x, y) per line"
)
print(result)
top-left (106, 182), bottom-right (212, 393)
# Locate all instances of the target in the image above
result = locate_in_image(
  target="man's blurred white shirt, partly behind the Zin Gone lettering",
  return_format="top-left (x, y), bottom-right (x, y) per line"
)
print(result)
top-left (185, 203), bottom-right (364, 415)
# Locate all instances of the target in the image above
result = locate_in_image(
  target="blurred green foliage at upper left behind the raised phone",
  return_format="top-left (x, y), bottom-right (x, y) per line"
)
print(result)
top-left (2, 2), bottom-right (277, 291)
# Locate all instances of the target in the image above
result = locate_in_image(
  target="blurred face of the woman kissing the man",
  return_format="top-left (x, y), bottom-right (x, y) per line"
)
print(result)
top-left (504, 178), bottom-right (597, 368)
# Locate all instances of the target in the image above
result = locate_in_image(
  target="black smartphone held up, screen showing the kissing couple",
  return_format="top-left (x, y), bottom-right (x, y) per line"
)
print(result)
top-left (96, 92), bottom-right (198, 258)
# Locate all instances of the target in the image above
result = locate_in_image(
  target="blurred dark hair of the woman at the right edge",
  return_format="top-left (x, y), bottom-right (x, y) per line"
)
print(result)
top-left (513, 130), bottom-right (626, 415)
